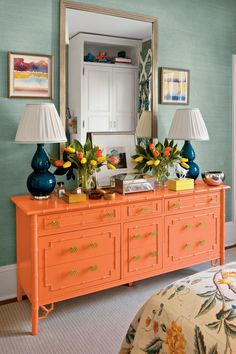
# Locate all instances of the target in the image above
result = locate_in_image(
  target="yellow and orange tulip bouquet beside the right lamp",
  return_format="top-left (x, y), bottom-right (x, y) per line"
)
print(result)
top-left (132, 139), bottom-right (189, 183)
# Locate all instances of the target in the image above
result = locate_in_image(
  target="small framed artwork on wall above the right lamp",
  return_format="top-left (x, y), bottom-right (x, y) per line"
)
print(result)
top-left (160, 68), bottom-right (190, 105)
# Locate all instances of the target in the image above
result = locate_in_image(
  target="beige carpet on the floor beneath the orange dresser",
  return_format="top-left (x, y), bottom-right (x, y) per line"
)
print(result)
top-left (0, 248), bottom-right (236, 354)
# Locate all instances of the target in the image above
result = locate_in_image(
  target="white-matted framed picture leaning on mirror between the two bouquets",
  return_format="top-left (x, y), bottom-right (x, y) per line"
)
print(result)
top-left (87, 132), bottom-right (136, 188)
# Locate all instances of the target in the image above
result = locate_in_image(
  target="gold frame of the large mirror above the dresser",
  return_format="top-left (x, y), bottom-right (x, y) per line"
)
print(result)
top-left (60, 0), bottom-right (158, 138)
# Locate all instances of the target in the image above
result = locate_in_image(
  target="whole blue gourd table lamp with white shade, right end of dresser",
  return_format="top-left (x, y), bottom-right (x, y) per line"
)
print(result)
top-left (168, 108), bottom-right (209, 179)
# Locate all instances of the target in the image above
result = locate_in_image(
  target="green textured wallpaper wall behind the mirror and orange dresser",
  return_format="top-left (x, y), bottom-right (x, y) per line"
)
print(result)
top-left (0, 0), bottom-right (236, 266)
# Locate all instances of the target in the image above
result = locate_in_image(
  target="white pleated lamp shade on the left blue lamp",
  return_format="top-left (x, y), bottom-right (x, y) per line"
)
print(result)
top-left (15, 103), bottom-right (67, 144)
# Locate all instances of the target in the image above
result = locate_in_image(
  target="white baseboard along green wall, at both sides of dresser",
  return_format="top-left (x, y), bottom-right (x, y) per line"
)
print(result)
top-left (0, 221), bottom-right (236, 301)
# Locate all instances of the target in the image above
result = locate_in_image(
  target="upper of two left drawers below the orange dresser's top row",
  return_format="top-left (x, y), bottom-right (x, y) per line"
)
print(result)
top-left (39, 225), bottom-right (120, 268)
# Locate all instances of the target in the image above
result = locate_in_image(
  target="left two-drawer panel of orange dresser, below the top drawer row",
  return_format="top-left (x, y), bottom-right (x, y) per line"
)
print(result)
top-left (39, 225), bottom-right (120, 298)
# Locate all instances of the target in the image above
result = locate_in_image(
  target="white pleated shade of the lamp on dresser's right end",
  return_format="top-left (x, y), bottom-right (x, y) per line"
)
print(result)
top-left (168, 108), bottom-right (209, 140)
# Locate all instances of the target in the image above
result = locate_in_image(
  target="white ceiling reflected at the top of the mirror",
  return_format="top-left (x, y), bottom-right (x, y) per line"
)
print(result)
top-left (66, 9), bottom-right (152, 39)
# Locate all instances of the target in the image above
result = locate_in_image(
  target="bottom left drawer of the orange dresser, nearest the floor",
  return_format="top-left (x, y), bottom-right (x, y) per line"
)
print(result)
top-left (39, 254), bottom-right (120, 298)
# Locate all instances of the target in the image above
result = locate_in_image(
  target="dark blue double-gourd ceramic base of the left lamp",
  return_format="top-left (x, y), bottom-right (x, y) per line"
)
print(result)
top-left (27, 144), bottom-right (56, 199)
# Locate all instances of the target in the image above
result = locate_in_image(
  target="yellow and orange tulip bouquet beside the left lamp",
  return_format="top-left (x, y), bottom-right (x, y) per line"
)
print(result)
top-left (51, 139), bottom-right (119, 189)
